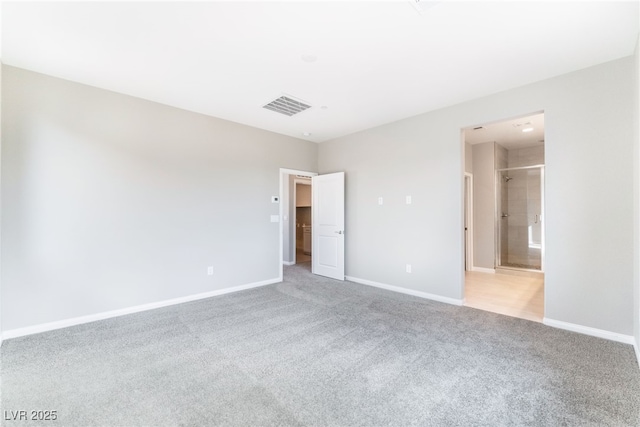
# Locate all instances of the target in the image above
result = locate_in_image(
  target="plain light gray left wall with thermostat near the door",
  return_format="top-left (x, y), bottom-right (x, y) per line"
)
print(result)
top-left (2, 66), bottom-right (317, 330)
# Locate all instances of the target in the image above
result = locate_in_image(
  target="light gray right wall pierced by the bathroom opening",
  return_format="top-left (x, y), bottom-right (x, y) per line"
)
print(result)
top-left (318, 57), bottom-right (637, 335)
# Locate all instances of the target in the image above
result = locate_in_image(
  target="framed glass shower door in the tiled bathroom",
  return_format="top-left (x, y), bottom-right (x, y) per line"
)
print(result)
top-left (496, 166), bottom-right (544, 271)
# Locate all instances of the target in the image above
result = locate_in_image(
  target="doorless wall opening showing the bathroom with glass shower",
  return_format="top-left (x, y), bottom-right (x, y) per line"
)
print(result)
top-left (463, 112), bottom-right (545, 322)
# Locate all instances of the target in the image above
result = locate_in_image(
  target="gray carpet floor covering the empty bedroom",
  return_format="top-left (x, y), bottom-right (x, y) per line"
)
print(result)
top-left (0, 264), bottom-right (640, 426)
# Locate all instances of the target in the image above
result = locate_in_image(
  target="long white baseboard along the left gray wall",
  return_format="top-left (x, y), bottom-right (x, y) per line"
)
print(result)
top-left (2, 279), bottom-right (282, 340)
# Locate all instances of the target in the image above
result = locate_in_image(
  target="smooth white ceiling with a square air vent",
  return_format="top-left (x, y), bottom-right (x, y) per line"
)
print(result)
top-left (2, 0), bottom-right (639, 142)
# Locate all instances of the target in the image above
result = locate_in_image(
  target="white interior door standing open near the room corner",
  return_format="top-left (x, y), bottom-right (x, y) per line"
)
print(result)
top-left (311, 172), bottom-right (344, 280)
